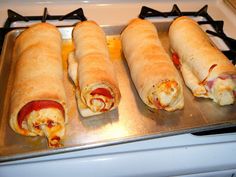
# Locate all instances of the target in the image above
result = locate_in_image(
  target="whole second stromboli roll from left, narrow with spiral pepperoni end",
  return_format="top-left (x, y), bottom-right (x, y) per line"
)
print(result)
top-left (68, 21), bottom-right (120, 117)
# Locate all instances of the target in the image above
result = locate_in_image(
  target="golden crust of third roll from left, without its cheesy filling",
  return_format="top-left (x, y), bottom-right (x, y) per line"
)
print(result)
top-left (121, 19), bottom-right (183, 110)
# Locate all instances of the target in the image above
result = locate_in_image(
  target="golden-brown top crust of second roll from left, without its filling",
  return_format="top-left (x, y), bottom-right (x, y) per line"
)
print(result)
top-left (73, 21), bottom-right (121, 113)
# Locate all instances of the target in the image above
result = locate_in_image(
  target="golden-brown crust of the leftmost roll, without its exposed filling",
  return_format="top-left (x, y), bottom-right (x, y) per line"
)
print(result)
top-left (10, 23), bottom-right (67, 136)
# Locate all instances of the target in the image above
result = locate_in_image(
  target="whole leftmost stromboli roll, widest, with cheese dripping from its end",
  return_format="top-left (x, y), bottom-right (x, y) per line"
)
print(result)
top-left (10, 23), bottom-right (67, 147)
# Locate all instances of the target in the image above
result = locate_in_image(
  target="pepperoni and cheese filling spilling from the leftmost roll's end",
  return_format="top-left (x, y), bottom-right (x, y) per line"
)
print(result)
top-left (17, 100), bottom-right (65, 147)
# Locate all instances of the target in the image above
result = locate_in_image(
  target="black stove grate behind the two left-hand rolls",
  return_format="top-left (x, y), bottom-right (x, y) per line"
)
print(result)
top-left (0, 8), bottom-right (87, 51)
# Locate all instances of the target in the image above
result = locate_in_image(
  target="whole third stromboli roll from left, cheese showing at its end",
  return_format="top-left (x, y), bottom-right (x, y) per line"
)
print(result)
top-left (121, 19), bottom-right (184, 111)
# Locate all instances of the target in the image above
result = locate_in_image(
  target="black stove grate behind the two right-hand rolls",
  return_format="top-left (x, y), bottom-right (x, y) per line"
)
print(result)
top-left (139, 4), bottom-right (236, 64)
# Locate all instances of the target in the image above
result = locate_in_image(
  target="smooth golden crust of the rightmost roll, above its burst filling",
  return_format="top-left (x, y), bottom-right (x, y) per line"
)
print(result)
top-left (169, 16), bottom-right (236, 81)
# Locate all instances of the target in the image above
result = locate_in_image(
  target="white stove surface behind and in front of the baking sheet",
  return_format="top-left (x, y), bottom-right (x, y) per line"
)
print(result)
top-left (0, 0), bottom-right (236, 177)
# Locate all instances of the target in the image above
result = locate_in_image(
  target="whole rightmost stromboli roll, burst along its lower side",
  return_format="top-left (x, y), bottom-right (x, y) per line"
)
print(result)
top-left (169, 16), bottom-right (236, 105)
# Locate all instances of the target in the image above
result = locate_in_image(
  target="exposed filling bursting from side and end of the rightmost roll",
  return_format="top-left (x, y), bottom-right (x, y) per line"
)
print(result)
top-left (172, 52), bottom-right (236, 105)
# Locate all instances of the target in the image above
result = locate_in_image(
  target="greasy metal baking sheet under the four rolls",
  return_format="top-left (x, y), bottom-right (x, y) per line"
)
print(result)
top-left (0, 22), bottom-right (236, 162)
